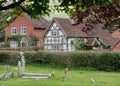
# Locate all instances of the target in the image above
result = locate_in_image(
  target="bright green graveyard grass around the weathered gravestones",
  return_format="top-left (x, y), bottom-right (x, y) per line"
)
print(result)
top-left (0, 65), bottom-right (120, 86)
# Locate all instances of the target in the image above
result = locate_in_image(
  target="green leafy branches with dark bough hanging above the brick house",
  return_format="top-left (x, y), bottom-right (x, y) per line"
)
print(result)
top-left (0, 0), bottom-right (50, 17)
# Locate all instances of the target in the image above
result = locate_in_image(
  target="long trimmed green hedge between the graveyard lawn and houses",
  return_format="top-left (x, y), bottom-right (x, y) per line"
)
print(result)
top-left (0, 51), bottom-right (120, 71)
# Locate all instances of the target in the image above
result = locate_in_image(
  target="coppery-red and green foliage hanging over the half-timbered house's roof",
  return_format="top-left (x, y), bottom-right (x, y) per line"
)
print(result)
top-left (57, 0), bottom-right (120, 28)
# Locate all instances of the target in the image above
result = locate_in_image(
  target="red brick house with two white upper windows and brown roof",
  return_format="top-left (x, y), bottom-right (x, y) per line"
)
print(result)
top-left (5, 13), bottom-right (49, 48)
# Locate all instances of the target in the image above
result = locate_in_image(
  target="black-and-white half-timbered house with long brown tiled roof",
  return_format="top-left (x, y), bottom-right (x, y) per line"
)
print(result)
top-left (43, 18), bottom-right (116, 51)
